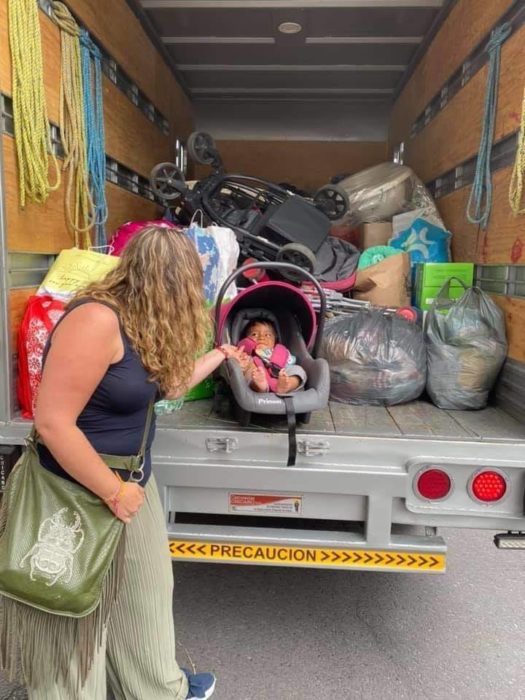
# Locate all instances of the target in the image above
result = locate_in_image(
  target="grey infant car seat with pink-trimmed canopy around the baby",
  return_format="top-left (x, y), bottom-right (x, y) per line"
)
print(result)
top-left (215, 262), bottom-right (330, 466)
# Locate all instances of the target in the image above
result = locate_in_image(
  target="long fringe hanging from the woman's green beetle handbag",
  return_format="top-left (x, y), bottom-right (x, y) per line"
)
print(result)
top-left (0, 528), bottom-right (125, 696)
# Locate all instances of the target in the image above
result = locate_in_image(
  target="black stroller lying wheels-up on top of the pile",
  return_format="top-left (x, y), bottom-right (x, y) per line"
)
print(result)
top-left (150, 132), bottom-right (348, 282)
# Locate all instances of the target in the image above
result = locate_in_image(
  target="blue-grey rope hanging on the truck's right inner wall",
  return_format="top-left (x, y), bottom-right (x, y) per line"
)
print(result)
top-left (467, 22), bottom-right (512, 229)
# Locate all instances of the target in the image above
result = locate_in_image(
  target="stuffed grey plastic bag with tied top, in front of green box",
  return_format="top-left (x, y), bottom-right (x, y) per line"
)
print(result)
top-left (425, 277), bottom-right (507, 410)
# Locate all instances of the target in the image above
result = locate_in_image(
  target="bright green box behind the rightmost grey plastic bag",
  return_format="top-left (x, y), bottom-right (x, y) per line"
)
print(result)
top-left (413, 263), bottom-right (474, 311)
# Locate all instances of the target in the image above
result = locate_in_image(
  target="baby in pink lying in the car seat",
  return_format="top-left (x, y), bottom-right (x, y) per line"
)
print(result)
top-left (237, 318), bottom-right (306, 394)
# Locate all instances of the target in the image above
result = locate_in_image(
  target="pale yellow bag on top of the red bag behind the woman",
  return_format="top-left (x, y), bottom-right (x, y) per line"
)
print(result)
top-left (38, 248), bottom-right (119, 301)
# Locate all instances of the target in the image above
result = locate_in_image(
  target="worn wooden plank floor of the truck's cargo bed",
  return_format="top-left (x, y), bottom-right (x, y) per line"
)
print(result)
top-left (158, 400), bottom-right (525, 441)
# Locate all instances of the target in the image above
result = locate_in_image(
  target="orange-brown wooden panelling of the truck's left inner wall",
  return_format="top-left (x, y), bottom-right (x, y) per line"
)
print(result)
top-left (0, 0), bottom-right (193, 350)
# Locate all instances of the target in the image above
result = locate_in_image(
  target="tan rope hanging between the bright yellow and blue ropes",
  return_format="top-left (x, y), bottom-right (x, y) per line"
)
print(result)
top-left (51, 0), bottom-right (95, 248)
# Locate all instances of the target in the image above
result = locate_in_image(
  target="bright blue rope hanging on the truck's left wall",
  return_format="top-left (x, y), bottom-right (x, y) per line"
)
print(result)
top-left (80, 29), bottom-right (108, 247)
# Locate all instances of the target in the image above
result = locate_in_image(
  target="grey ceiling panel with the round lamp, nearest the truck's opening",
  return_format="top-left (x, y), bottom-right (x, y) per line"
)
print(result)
top-left (142, 7), bottom-right (438, 40)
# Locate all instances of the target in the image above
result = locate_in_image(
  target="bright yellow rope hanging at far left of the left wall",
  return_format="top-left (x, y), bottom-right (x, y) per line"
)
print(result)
top-left (9, 0), bottom-right (60, 207)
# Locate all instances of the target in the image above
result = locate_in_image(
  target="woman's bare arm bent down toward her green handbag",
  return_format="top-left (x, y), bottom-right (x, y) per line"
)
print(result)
top-left (35, 303), bottom-right (143, 522)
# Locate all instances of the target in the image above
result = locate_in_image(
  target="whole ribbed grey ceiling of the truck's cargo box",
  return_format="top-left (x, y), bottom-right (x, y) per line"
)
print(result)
top-left (137, 0), bottom-right (448, 130)
